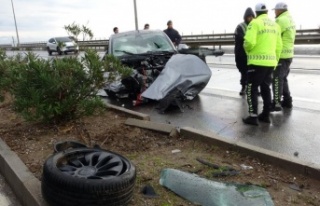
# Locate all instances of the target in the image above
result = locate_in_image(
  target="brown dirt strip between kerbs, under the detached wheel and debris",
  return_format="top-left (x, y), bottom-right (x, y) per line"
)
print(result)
top-left (0, 104), bottom-right (320, 206)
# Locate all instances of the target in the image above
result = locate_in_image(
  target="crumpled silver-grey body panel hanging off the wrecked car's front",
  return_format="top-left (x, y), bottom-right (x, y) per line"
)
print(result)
top-left (141, 54), bottom-right (212, 100)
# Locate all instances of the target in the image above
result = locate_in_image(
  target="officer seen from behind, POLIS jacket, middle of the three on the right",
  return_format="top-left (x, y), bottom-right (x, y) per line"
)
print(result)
top-left (243, 3), bottom-right (282, 125)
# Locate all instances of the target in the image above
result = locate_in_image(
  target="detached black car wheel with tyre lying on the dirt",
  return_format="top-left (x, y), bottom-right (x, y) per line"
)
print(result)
top-left (41, 148), bottom-right (136, 206)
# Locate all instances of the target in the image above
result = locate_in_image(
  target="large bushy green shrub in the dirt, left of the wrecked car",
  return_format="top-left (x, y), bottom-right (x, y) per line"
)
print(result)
top-left (11, 50), bottom-right (104, 123)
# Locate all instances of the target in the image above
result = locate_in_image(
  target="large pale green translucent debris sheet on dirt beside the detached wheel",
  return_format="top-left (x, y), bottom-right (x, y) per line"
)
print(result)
top-left (159, 169), bottom-right (274, 206)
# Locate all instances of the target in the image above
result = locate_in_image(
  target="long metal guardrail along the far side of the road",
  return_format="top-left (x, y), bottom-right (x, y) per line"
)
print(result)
top-left (0, 29), bottom-right (320, 50)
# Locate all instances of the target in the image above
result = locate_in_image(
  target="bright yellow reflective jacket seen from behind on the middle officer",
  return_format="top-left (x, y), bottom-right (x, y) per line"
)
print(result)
top-left (243, 14), bottom-right (282, 67)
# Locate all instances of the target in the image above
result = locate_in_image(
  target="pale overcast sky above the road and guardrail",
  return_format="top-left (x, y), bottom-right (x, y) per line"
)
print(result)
top-left (0, 0), bottom-right (320, 44)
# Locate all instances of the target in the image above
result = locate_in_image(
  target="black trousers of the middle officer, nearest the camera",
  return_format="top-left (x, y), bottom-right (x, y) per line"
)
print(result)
top-left (247, 65), bottom-right (274, 116)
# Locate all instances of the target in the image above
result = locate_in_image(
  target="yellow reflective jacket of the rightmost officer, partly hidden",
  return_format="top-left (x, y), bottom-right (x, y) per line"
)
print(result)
top-left (276, 11), bottom-right (296, 59)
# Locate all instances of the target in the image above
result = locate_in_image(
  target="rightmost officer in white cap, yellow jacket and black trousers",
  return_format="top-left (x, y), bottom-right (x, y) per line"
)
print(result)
top-left (272, 2), bottom-right (296, 111)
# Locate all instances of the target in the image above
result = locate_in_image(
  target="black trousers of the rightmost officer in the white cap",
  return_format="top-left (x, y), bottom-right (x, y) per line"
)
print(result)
top-left (272, 58), bottom-right (292, 103)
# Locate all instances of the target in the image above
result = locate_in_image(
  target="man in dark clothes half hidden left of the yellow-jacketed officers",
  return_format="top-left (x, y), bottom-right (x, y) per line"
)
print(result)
top-left (234, 7), bottom-right (255, 95)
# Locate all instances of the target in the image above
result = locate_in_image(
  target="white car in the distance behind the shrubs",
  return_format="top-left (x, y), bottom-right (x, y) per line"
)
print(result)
top-left (47, 37), bottom-right (79, 55)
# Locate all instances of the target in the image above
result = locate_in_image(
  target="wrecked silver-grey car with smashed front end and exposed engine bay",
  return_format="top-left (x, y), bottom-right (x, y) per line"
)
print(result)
top-left (104, 30), bottom-right (223, 109)
